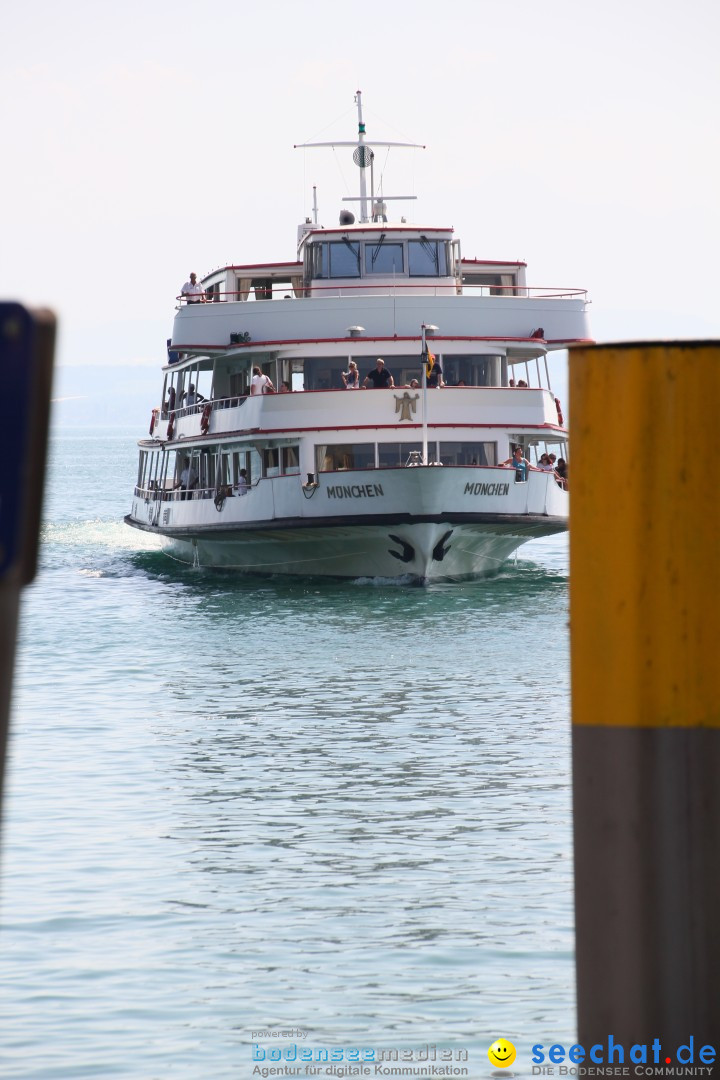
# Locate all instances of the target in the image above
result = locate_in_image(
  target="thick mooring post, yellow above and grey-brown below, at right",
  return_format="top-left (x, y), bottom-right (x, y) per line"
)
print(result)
top-left (569, 341), bottom-right (720, 1045)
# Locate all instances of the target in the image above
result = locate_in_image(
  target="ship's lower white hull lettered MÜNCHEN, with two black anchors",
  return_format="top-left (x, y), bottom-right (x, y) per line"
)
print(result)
top-left (126, 468), bottom-right (568, 582)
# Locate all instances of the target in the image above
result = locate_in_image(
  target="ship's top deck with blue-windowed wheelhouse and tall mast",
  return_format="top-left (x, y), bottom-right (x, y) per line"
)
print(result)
top-left (171, 91), bottom-right (588, 360)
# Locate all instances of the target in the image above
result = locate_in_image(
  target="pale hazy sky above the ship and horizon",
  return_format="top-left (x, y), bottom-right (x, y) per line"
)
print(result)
top-left (0, 0), bottom-right (720, 365)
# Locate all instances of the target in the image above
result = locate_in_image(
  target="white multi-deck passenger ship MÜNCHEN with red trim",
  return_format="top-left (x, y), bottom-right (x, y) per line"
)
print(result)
top-left (125, 92), bottom-right (588, 582)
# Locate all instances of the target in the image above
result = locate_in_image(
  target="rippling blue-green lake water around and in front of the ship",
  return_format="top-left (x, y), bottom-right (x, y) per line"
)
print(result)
top-left (0, 429), bottom-right (574, 1080)
